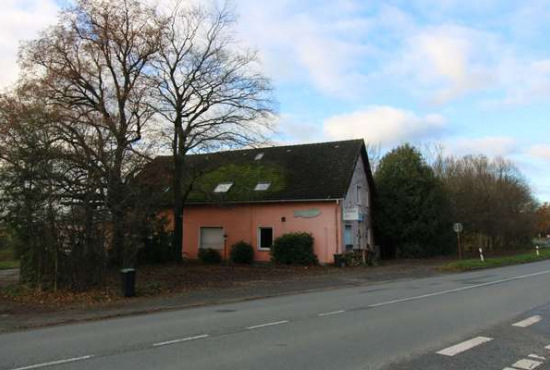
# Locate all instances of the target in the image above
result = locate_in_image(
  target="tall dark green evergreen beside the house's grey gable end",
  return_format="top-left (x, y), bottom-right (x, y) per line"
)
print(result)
top-left (373, 144), bottom-right (456, 258)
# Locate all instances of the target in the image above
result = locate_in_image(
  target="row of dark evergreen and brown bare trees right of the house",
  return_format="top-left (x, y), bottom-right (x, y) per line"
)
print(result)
top-left (374, 144), bottom-right (540, 258)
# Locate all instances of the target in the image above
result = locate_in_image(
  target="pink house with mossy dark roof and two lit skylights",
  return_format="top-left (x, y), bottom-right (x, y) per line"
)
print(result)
top-left (144, 140), bottom-right (374, 263)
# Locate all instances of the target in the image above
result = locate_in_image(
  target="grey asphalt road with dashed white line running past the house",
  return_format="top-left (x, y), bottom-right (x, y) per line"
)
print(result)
top-left (0, 261), bottom-right (550, 370)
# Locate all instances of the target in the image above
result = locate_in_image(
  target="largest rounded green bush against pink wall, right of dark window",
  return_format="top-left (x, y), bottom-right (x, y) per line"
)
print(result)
top-left (271, 233), bottom-right (319, 265)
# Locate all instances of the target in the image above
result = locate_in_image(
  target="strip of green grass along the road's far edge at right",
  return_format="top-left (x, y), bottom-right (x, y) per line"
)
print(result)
top-left (440, 249), bottom-right (550, 271)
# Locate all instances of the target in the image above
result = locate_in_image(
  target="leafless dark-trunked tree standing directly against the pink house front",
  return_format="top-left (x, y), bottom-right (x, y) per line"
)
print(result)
top-left (153, 2), bottom-right (273, 250)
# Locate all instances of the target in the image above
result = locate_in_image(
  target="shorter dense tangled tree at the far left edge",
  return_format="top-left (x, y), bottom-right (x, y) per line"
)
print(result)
top-left (0, 89), bottom-right (111, 290)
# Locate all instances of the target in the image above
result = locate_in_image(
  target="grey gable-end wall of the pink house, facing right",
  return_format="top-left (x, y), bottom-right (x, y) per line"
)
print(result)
top-left (342, 157), bottom-right (374, 249)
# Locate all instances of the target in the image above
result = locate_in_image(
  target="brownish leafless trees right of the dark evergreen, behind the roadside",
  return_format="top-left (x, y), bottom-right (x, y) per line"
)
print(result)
top-left (432, 152), bottom-right (536, 250)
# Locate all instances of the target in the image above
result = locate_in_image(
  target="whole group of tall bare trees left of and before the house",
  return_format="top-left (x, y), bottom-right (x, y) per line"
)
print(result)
top-left (0, 0), bottom-right (273, 290)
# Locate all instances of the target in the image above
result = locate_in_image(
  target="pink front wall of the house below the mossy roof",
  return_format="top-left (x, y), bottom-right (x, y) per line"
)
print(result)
top-left (183, 202), bottom-right (342, 263)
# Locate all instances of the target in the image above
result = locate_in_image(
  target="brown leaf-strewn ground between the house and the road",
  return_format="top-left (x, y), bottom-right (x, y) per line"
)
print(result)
top-left (0, 264), bottom-right (341, 310)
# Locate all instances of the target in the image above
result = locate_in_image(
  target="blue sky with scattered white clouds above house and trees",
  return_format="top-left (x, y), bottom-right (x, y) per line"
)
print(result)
top-left (0, 0), bottom-right (550, 201)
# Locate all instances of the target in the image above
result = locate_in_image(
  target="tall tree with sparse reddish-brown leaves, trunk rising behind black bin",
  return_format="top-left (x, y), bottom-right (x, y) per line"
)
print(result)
top-left (21, 0), bottom-right (163, 264)
